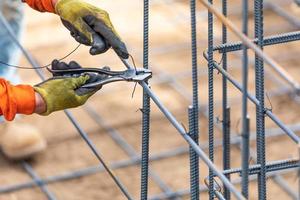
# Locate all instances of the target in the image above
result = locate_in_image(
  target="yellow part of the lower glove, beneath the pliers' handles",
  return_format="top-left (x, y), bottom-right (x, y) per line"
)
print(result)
top-left (34, 75), bottom-right (97, 115)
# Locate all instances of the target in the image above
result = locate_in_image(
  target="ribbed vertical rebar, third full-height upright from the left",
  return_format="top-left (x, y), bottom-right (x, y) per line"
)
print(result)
top-left (208, 0), bottom-right (214, 200)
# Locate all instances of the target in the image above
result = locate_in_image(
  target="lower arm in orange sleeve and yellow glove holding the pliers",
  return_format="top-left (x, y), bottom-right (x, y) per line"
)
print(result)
top-left (0, 61), bottom-right (100, 121)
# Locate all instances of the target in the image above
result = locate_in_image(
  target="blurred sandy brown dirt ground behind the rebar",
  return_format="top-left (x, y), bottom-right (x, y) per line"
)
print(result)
top-left (0, 0), bottom-right (300, 200)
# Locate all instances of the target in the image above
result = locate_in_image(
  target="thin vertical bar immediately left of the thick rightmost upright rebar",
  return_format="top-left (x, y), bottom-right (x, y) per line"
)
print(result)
top-left (242, 0), bottom-right (249, 198)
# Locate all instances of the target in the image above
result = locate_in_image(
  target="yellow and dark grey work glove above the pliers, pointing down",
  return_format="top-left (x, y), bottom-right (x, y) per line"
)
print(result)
top-left (55, 0), bottom-right (129, 59)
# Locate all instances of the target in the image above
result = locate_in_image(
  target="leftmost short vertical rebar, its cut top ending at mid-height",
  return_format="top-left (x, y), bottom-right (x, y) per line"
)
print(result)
top-left (188, 106), bottom-right (199, 200)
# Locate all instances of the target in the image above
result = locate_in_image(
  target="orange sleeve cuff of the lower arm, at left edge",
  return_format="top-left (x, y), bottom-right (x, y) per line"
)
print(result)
top-left (0, 78), bottom-right (35, 121)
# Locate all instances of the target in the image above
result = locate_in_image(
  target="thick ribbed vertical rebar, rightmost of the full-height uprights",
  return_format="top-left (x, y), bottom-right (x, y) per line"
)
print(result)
top-left (254, 0), bottom-right (266, 200)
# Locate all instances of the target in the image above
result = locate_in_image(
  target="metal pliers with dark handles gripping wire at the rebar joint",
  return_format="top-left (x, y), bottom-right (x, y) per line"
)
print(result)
top-left (48, 68), bottom-right (152, 88)
